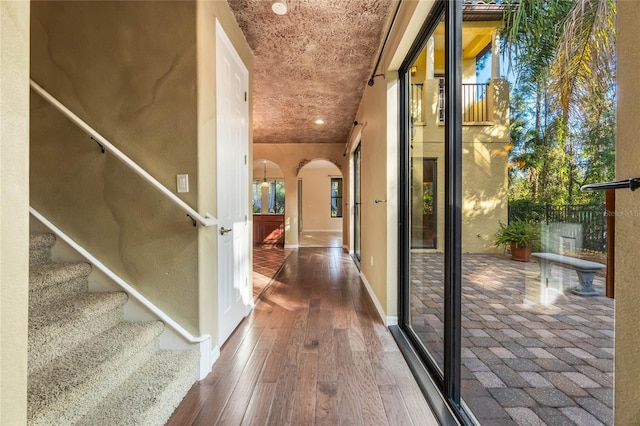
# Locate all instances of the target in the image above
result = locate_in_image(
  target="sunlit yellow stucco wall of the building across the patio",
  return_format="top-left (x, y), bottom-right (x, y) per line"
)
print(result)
top-left (412, 79), bottom-right (510, 253)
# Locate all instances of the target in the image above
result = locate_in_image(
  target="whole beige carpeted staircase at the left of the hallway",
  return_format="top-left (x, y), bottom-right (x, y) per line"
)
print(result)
top-left (27, 234), bottom-right (199, 426)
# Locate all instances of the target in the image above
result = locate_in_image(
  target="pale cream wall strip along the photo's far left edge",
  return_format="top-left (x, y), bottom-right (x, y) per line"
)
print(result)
top-left (0, 1), bottom-right (29, 425)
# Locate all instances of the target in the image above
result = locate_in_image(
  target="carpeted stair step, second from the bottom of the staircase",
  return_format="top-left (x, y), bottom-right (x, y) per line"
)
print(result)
top-left (27, 321), bottom-right (164, 425)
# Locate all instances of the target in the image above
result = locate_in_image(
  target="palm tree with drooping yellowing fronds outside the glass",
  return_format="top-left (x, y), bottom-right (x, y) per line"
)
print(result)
top-left (503, 0), bottom-right (616, 202)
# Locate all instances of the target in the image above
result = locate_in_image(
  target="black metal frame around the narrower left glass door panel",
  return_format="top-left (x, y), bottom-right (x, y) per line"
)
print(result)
top-left (390, 0), bottom-right (474, 424)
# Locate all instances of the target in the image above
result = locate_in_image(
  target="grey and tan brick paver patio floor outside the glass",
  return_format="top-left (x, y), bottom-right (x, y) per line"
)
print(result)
top-left (411, 254), bottom-right (614, 426)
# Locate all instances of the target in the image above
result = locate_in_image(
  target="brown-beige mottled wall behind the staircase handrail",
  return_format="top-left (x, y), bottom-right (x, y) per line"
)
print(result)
top-left (31, 1), bottom-right (199, 334)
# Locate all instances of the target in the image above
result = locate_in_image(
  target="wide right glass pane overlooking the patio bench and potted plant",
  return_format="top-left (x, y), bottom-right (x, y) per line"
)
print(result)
top-left (460, 6), bottom-right (624, 425)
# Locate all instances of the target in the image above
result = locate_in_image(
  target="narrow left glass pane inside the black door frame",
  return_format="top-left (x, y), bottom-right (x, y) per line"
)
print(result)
top-left (406, 23), bottom-right (444, 374)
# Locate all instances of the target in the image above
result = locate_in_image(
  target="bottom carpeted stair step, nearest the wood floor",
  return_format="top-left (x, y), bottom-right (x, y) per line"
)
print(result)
top-left (78, 351), bottom-right (200, 426)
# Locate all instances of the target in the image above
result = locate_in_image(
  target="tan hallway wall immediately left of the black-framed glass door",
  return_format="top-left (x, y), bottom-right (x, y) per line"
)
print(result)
top-left (344, 1), bottom-right (433, 317)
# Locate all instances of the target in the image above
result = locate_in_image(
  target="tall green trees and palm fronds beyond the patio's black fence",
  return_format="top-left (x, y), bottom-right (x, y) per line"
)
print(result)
top-left (503, 0), bottom-right (616, 204)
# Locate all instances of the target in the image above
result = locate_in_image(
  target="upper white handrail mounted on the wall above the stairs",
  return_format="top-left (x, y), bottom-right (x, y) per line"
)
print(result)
top-left (29, 80), bottom-right (218, 226)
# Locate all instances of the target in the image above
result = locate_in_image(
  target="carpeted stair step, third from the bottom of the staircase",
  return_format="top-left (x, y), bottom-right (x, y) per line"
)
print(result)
top-left (29, 292), bottom-right (128, 371)
